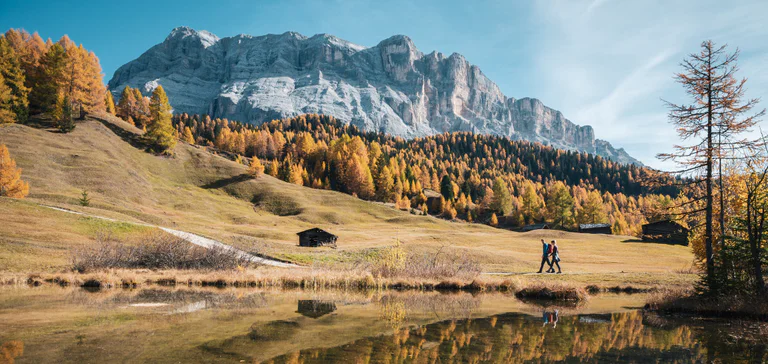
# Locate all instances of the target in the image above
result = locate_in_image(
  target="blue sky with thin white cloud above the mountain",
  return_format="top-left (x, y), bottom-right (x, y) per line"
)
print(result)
top-left (0, 0), bottom-right (768, 169)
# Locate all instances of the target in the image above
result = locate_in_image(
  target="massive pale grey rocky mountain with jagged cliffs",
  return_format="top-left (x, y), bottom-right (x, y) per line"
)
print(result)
top-left (108, 27), bottom-right (640, 164)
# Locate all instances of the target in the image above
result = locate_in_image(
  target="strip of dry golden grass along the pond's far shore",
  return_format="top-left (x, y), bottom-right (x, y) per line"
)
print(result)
top-left (0, 268), bottom-right (693, 301)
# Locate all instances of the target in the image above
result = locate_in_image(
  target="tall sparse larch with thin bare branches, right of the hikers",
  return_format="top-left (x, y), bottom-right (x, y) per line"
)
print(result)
top-left (658, 41), bottom-right (765, 284)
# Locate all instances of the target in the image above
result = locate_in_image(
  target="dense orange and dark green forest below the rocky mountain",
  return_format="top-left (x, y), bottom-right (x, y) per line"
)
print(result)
top-left (132, 110), bottom-right (677, 235)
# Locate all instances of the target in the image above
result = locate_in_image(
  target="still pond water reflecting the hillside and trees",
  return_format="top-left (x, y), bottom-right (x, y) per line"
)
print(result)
top-left (0, 287), bottom-right (768, 363)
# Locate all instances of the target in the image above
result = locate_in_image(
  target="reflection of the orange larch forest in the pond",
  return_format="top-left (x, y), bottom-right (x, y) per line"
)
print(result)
top-left (268, 312), bottom-right (706, 363)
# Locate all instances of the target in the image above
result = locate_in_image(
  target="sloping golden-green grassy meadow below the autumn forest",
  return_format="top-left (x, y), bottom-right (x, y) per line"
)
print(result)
top-left (0, 117), bottom-right (692, 282)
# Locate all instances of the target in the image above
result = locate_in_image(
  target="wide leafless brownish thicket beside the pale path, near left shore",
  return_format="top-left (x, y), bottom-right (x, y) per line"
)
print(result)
top-left (72, 231), bottom-right (253, 273)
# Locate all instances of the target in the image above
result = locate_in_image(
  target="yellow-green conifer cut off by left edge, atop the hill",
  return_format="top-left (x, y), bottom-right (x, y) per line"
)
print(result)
top-left (0, 36), bottom-right (29, 123)
